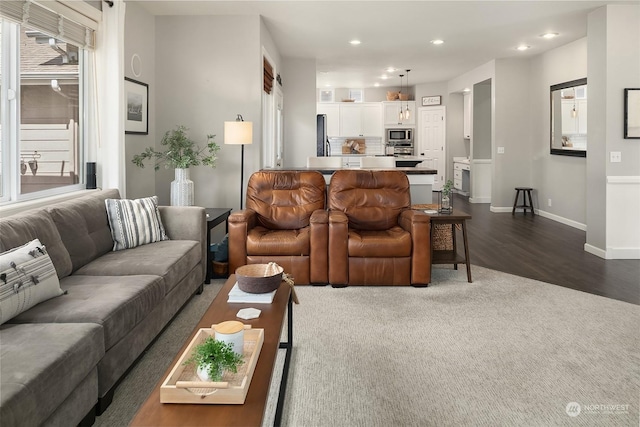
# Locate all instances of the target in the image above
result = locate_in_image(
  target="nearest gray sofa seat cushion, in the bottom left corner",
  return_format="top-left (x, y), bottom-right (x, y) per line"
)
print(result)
top-left (0, 323), bottom-right (104, 426)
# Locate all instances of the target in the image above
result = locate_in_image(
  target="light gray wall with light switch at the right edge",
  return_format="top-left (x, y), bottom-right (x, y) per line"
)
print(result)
top-left (587, 5), bottom-right (640, 250)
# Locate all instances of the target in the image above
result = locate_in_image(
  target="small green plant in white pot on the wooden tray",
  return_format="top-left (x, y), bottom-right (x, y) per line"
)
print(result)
top-left (184, 337), bottom-right (244, 382)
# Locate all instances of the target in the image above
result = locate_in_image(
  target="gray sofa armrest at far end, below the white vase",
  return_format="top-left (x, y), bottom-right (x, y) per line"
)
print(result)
top-left (158, 206), bottom-right (209, 280)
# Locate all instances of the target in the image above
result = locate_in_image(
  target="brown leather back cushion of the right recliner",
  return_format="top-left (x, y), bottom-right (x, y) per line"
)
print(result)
top-left (328, 170), bottom-right (411, 230)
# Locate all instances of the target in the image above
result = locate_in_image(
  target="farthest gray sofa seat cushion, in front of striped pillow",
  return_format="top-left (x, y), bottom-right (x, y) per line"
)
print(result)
top-left (75, 240), bottom-right (202, 294)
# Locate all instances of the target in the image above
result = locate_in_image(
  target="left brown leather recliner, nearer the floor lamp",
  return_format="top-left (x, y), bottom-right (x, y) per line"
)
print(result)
top-left (229, 171), bottom-right (328, 284)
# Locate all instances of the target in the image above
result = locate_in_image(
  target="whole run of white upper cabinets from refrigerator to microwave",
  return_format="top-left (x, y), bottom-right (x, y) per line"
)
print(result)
top-left (316, 102), bottom-right (383, 137)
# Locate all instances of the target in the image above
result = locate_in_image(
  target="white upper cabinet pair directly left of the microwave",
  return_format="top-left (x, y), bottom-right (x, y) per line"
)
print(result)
top-left (340, 102), bottom-right (382, 137)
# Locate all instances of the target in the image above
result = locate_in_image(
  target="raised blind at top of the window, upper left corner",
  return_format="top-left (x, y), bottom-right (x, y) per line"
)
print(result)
top-left (0, 0), bottom-right (100, 49)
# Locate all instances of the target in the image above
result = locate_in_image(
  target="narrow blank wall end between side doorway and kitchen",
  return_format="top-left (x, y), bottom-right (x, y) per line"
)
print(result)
top-left (282, 58), bottom-right (316, 168)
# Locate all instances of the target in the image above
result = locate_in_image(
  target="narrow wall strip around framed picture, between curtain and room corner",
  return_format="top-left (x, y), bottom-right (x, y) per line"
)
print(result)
top-left (124, 2), bottom-right (158, 199)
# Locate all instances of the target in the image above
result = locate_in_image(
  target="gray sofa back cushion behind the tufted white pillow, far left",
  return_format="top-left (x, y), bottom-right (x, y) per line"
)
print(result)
top-left (0, 209), bottom-right (72, 279)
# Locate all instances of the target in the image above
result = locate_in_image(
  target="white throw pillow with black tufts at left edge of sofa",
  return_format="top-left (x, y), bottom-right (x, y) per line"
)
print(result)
top-left (0, 239), bottom-right (63, 325)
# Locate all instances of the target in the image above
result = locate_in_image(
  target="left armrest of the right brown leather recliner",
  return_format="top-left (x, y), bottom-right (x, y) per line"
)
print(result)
top-left (329, 211), bottom-right (349, 285)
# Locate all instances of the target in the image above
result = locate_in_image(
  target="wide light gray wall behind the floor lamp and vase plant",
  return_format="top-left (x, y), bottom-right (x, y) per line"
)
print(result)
top-left (155, 16), bottom-right (262, 208)
